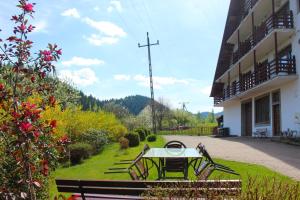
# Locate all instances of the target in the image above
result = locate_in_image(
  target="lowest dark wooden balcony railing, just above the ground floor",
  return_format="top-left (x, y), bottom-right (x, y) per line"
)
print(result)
top-left (214, 56), bottom-right (296, 105)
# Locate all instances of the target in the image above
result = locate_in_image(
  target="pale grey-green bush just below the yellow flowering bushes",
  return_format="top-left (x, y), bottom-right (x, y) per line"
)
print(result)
top-left (75, 129), bottom-right (108, 154)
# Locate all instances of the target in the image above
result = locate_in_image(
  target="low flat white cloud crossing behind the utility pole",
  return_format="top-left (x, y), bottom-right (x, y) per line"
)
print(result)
top-left (133, 74), bottom-right (189, 89)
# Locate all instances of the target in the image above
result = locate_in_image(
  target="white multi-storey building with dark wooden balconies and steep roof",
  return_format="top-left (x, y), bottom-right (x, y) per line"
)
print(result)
top-left (211, 0), bottom-right (300, 136)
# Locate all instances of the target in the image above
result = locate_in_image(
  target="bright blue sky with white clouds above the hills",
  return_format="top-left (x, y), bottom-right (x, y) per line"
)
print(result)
top-left (0, 0), bottom-right (229, 113)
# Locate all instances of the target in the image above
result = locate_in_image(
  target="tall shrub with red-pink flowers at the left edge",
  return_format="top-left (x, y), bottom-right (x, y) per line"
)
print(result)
top-left (0, 0), bottom-right (68, 200)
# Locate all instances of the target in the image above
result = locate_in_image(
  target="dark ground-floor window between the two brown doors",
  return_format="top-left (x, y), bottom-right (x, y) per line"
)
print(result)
top-left (255, 95), bottom-right (270, 124)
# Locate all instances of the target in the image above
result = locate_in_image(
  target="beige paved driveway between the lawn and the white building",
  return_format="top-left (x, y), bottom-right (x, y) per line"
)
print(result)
top-left (164, 136), bottom-right (300, 180)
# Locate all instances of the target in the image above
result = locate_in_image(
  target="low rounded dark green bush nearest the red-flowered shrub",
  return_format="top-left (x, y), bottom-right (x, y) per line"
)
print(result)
top-left (69, 142), bottom-right (93, 165)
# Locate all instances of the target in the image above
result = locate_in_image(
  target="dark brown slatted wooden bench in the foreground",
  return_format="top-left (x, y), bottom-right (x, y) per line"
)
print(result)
top-left (55, 179), bottom-right (242, 200)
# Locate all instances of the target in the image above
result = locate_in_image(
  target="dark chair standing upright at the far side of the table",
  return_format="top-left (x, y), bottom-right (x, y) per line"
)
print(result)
top-left (160, 140), bottom-right (188, 179)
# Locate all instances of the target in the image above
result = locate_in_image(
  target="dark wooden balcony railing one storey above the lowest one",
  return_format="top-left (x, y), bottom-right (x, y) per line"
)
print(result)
top-left (231, 11), bottom-right (294, 64)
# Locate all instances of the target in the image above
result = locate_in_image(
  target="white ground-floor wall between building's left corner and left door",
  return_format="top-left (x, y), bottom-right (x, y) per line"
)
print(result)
top-left (224, 101), bottom-right (241, 136)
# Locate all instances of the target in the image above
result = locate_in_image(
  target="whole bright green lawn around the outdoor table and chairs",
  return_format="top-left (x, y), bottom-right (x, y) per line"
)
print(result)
top-left (50, 136), bottom-right (292, 199)
